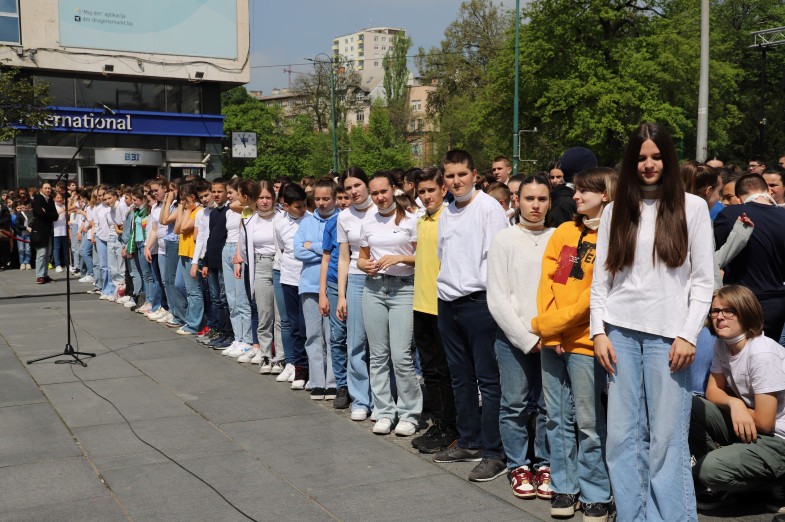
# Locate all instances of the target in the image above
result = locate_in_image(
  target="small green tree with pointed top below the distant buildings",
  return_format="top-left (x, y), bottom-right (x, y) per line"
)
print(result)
top-left (349, 100), bottom-right (412, 172)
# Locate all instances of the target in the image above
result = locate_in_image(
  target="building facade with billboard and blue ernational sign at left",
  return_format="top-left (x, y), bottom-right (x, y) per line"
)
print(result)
top-left (0, 0), bottom-right (250, 187)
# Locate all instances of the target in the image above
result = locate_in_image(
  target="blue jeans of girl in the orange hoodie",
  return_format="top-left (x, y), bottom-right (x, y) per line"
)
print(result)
top-left (541, 342), bottom-right (611, 502)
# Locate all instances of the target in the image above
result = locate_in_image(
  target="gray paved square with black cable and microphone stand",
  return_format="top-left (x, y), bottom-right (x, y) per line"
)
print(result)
top-left (0, 271), bottom-right (771, 521)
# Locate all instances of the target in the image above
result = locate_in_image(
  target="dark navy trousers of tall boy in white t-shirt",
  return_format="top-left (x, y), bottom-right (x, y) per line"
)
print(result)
top-left (439, 292), bottom-right (505, 460)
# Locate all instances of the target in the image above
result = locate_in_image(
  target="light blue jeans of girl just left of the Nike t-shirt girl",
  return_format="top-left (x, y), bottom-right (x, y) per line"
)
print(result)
top-left (346, 274), bottom-right (374, 412)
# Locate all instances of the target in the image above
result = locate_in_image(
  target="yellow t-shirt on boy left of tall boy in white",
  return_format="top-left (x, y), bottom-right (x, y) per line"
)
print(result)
top-left (413, 206), bottom-right (445, 315)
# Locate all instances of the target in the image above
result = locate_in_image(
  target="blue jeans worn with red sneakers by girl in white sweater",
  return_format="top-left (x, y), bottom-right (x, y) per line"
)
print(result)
top-left (494, 328), bottom-right (553, 474)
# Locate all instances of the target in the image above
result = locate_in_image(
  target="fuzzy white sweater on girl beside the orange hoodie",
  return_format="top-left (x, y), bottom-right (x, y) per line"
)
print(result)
top-left (487, 225), bottom-right (555, 353)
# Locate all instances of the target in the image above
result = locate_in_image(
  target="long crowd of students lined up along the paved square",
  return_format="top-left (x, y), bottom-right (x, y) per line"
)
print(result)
top-left (1, 124), bottom-right (785, 521)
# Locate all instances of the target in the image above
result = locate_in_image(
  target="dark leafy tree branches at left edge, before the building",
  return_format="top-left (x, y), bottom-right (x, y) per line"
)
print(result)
top-left (0, 63), bottom-right (51, 141)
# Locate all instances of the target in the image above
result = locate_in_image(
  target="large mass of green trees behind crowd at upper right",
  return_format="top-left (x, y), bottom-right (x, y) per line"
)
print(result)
top-left (417, 0), bottom-right (785, 170)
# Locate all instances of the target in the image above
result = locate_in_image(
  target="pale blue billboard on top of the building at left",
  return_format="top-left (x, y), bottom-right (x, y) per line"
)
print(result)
top-left (59, 0), bottom-right (237, 58)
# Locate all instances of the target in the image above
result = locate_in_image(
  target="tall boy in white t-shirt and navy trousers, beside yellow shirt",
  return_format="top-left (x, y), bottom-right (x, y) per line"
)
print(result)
top-left (433, 150), bottom-right (509, 482)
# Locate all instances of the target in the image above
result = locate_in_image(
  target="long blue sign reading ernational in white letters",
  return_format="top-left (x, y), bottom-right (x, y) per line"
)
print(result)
top-left (38, 107), bottom-right (224, 138)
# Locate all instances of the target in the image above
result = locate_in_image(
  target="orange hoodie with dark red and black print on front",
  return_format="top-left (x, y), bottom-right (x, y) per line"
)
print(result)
top-left (532, 221), bottom-right (597, 357)
